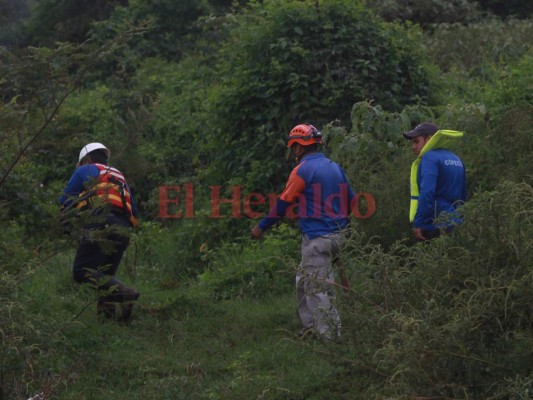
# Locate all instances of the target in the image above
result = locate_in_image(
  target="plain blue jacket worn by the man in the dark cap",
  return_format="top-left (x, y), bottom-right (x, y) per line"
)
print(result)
top-left (413, 149), bottom-right (466, 231)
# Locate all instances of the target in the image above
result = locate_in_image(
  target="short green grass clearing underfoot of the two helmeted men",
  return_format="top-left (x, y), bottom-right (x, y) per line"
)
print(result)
top-left (21, 252), bottom-right (368, 400)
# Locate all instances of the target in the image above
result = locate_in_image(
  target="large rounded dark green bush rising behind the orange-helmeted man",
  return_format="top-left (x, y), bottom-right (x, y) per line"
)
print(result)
top-left (206, 0), bottom-right (429, 194)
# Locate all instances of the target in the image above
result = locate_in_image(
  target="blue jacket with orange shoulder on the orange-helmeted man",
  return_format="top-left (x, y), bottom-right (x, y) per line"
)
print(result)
top-left (259, 153), bottom-right (355, 239)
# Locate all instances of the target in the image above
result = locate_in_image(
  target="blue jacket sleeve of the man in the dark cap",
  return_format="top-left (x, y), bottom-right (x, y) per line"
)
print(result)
top-left (413, 153), bottom-right (439, 228)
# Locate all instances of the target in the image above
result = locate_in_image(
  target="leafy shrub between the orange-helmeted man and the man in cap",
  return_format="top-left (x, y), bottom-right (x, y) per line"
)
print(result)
top-left (324, 102), bottom-right (438, 245)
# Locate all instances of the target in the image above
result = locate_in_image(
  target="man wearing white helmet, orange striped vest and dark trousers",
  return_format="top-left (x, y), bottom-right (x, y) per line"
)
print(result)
top-left (60, 143), bottom-right (140, 321)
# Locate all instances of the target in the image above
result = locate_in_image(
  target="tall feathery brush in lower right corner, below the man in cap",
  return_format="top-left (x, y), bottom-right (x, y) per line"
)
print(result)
top-left (343, 181), bottom-right (533, 399)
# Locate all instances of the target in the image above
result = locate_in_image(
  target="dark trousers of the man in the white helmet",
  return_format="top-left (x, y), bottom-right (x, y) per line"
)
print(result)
top-left (72, 214), bottom-right (130, 289)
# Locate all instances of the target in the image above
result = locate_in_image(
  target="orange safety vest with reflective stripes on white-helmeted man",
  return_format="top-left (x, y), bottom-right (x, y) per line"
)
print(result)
top-left (76, 163), bottom-right (138, 226)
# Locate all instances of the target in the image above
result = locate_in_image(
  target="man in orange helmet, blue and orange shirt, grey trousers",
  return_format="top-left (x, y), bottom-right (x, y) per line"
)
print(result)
top-left (251, 124), bottom-right (355, 339)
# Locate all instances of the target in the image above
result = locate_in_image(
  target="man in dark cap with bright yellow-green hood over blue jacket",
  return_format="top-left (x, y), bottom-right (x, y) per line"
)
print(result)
top-left (403, 122), bottom-right (466, 240)
